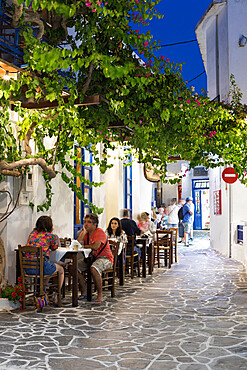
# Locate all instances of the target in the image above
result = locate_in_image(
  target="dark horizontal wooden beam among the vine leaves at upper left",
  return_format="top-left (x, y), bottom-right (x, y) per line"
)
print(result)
top-left (17, 94), bottom-right (100, 109)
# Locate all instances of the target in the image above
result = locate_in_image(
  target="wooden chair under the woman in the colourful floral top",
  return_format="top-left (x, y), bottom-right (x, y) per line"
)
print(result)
top-left (18, 245), bottom-right (62, 309)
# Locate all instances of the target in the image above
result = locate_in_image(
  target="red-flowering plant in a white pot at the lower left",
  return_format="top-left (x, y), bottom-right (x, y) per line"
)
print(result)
top-left (0, 277), bottom-right (26, 311)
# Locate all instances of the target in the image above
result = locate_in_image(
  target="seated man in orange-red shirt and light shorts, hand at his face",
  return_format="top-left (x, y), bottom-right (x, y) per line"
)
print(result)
top-left (69, 213), bottom-right (113, 304)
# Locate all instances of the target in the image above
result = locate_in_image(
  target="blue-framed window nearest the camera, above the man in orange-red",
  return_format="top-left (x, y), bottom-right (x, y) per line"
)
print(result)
top-left (74, 147), bottom-right (93, 238)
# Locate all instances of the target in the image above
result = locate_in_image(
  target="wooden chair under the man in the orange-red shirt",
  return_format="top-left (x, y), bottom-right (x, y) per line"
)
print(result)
top-left (102, 240), bottom-right (120, 297)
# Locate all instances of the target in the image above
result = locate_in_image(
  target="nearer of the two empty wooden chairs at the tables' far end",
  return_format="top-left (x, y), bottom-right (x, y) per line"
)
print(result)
top-left (156, 230), bottom-right (173, 268)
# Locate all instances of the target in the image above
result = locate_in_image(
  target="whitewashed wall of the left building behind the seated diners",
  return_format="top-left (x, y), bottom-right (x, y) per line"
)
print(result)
top-left (0, 136), bottom-right (153, 283)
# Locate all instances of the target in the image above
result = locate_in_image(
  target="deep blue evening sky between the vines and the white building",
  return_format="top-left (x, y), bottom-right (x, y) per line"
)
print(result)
top-left (141, 0), bottom-right (211, 93)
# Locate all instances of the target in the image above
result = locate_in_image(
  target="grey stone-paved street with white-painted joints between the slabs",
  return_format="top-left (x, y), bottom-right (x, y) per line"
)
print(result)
top-left (0, 232), bottom-right (247, 370)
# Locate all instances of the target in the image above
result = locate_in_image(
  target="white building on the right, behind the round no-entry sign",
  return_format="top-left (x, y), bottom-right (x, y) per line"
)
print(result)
top-left (196, 0), bottom-right (247, 267)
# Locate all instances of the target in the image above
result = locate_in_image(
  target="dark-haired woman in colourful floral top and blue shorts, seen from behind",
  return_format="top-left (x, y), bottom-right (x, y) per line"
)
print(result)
top-left (25, 216), bottom-right (64, 305)
